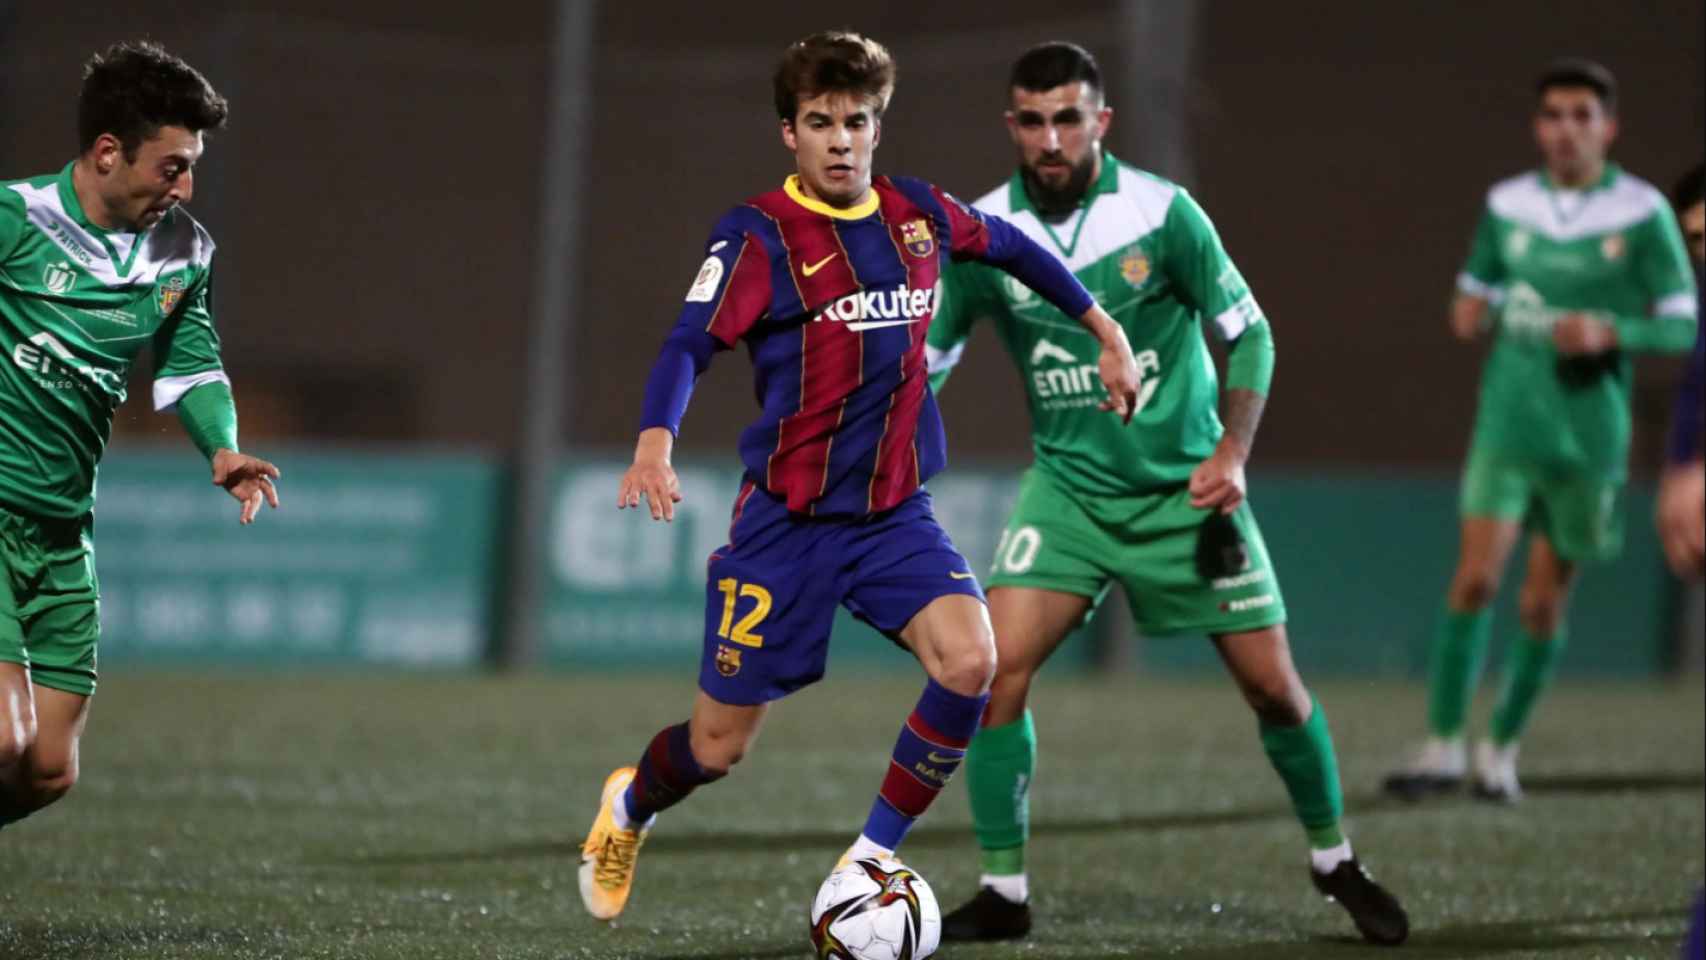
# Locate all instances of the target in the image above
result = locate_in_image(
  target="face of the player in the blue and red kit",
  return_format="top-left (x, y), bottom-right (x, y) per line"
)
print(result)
top-left (781, 94), bottom-right (882, 206)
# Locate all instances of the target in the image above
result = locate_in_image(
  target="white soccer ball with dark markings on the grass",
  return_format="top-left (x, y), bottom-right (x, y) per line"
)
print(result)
top-left (812, 858), bottom-right (942, 960)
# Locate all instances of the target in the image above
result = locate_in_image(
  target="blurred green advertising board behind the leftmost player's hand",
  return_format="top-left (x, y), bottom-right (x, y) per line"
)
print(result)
top-left (96, 450), bottom-right (500, 667)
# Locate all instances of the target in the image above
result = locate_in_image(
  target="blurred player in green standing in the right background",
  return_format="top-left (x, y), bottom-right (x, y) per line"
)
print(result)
top-left (1385, 60), bottom-right (1696, 801)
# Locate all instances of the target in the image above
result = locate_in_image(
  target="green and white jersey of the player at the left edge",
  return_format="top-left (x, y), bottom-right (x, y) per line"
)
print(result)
top-left (0, 165), bottom-right (229, 517)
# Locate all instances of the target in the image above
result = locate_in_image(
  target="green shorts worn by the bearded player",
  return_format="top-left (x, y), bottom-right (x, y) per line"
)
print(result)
top-left (984, 466), bottom-right (1285, 636)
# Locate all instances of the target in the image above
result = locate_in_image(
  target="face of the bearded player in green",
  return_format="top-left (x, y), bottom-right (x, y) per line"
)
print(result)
top-left (1007, 80), bottom-right (1114, 210)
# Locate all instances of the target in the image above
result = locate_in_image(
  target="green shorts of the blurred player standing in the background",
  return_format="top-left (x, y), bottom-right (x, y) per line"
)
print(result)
top-left (1460, 448), bottom-right (1622, 563)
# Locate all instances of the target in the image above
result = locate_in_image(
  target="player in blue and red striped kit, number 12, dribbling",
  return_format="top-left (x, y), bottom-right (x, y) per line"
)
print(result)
top-left (580, 32), bottom-right (1138, 919)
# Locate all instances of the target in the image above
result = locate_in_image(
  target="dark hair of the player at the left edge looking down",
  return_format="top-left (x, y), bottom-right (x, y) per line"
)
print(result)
top-left (77, 39), bottom-right (229, 160)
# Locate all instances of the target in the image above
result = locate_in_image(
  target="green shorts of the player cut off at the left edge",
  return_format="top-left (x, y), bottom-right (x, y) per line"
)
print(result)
top-left (0, 510), bottom-right (101, 697)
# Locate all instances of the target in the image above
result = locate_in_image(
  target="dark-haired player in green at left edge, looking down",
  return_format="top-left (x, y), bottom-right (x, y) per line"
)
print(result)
top-left (0, 43), bottom-right (278, 827)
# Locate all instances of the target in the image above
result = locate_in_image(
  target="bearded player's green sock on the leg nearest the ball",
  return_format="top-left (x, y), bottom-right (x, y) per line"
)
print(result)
top-left (966, 709), bottom-right (1037, 875)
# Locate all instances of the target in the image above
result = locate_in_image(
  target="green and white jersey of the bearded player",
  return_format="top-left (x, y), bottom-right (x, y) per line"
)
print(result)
top-left (928, 153), bottom-right (1266, 496)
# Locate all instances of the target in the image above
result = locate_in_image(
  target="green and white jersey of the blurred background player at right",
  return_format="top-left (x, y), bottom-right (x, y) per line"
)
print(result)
top-left (1457, 164), bottom-right (1696, 479)
